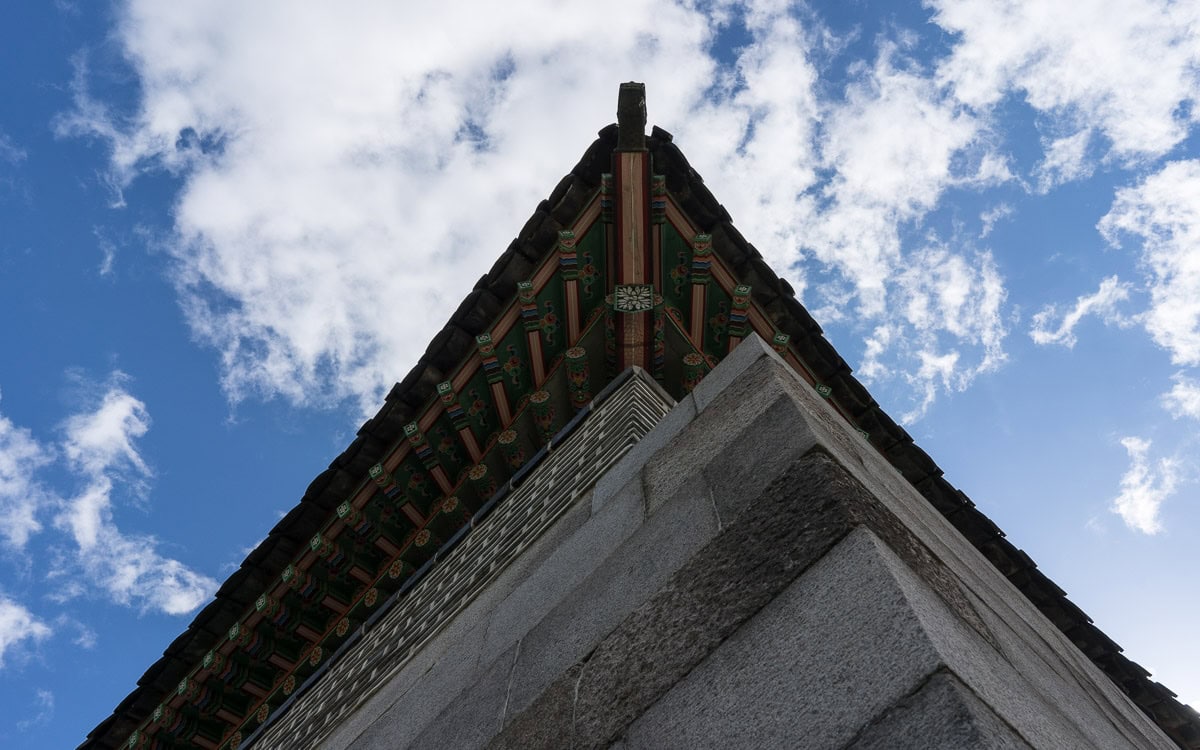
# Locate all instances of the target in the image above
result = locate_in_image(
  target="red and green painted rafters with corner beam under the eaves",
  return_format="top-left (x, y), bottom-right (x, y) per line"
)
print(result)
top-left (117, 114), bottom-right (878, 748)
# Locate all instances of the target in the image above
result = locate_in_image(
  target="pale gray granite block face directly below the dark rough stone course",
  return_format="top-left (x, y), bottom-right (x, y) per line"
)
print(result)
top-left (614, 529), bottom-right (941, 750)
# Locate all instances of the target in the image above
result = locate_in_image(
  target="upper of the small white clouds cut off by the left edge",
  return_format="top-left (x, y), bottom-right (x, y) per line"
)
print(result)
top-left (0, 391), bottom-right (52, 550)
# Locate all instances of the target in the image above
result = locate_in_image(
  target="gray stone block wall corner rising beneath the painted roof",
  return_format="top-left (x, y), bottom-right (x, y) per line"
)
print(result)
top-left (333, 336), bottom-right (1174, 750)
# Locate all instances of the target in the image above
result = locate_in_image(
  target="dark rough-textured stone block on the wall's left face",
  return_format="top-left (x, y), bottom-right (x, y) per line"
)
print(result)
top-left (502, 455), bottom-right (853, 746)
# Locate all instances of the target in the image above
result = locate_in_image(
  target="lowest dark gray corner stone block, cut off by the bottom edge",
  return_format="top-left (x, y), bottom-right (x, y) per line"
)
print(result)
top-left (847, 672), bottom-right (1031, 750)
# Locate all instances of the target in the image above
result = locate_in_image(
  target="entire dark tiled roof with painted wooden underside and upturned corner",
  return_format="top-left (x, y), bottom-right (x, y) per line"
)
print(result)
top-left (80, 84), bottom-right (1200, 750)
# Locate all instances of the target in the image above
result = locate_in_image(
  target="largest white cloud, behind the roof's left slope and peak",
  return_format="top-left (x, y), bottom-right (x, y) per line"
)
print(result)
top-left (60, 0), bottom-right (729, 410)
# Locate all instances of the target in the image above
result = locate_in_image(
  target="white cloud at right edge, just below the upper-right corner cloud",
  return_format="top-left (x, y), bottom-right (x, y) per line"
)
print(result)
top-left (1098, 160), bottom-right (1200, 365)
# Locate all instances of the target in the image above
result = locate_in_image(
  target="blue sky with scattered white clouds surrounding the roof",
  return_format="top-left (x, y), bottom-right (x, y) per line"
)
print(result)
top-left (0, 0), bottom-right (1200, 748)
